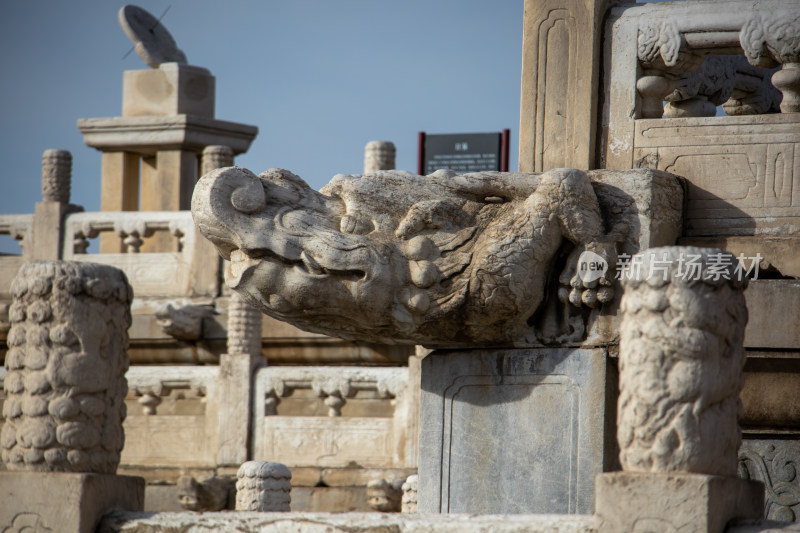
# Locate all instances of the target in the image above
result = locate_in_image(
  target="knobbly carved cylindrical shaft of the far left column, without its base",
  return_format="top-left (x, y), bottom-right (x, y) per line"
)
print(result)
top-left (0, 261), bottom-right (133, 474)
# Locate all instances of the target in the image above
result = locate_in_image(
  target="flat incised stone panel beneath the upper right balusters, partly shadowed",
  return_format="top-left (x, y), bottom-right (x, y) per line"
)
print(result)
top-left (632, 114), bottom-right (800, 236)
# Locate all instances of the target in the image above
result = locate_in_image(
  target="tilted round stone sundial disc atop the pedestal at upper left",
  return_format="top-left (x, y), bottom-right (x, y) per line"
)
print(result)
top-left (119, 5), bottom-right (186, 68)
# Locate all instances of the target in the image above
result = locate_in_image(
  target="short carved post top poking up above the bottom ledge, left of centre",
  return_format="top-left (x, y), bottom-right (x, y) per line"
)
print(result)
top-left (236, 461), bottom-right (292, 512)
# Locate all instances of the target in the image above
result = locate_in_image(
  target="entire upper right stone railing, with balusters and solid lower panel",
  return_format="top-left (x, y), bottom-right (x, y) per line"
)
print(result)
top-left (597, 0), bottom-right (800, 237)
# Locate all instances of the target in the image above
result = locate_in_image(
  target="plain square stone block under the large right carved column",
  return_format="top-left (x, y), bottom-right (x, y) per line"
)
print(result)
top-left (596, 472), bottom-right (764, 533)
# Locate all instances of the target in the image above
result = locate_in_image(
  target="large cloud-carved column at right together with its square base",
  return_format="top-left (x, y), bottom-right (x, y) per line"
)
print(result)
top-left (597, 246), bottom-right (764, 533)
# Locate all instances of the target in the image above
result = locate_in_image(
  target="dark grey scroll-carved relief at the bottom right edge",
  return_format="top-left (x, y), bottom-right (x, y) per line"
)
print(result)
top-left (739, 440), bottom-right (800, 522)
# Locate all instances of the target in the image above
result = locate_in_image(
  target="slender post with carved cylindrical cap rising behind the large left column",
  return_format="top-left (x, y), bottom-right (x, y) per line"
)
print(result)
top-left (29, 150), bottom-right (72, 259)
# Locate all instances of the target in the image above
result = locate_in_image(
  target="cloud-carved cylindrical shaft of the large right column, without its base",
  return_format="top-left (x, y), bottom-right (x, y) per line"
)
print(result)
top-left (617, 246), bottom-right (747, 476)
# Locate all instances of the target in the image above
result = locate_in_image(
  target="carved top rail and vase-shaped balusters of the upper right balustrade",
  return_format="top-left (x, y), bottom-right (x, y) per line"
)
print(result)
top-left (614, 0), bottom-right (800, 118)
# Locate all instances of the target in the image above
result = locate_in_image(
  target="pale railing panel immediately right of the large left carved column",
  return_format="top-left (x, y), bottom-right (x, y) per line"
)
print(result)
top-left (122, 366), bottom-right (219, 466)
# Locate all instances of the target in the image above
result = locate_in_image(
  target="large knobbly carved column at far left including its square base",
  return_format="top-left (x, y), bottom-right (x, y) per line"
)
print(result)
top-left (0, 260), bottom-right (144, 531)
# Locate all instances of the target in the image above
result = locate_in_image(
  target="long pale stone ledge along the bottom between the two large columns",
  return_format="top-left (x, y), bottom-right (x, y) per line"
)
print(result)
top-left (98, 512), bottom-right (597, 533)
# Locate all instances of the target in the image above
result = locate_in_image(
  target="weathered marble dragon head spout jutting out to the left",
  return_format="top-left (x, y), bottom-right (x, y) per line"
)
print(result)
top-left (192, 167), bottom-right (627, 344)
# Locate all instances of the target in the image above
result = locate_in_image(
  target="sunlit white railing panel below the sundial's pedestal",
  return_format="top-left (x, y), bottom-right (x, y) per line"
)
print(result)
top-left (63, 211), bottom-right (219, 297)
